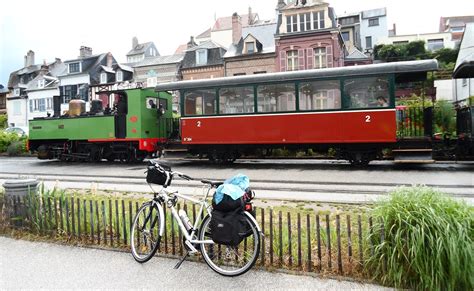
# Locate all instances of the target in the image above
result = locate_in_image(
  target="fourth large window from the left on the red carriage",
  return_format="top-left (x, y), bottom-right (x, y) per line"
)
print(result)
top-left (299, 80), bottom-right (341, 110)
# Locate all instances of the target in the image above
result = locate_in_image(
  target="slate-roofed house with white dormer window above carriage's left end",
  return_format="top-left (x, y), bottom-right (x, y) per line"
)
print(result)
top-left (181, 41), bottom-right (226, 80)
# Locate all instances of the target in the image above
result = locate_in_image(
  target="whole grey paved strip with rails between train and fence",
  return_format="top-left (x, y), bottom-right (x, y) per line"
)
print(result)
top-left (0, 157), bottom-right (474, 203)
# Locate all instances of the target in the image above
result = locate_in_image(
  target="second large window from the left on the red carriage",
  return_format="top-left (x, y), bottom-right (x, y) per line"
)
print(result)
top-left (219, 87), bottom-right (255, 114)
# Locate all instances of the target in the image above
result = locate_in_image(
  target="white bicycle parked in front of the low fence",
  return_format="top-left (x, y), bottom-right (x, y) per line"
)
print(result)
top-left (130, 161), bottom-right (263, 277)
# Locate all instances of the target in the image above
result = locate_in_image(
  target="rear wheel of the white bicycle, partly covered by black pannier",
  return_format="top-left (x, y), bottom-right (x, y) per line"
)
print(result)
top-left (199, 215), bottom-right (260, 277)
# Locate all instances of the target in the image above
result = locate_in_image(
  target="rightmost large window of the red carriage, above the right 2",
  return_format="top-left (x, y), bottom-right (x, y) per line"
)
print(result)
top-left (344, 77), bottom-right (390, 108)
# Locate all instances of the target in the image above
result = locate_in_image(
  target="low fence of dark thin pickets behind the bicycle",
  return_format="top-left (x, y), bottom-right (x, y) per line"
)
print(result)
top-left (0, 196), bottom-right (382, 276)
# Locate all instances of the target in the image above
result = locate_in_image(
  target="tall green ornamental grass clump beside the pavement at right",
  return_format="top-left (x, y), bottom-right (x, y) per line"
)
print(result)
top-left (367, 187), bottom-right (474, 290)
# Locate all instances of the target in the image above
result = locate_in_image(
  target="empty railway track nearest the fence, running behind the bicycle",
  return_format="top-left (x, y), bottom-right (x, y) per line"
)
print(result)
top-left (0, 172), bottom-right (474, 204)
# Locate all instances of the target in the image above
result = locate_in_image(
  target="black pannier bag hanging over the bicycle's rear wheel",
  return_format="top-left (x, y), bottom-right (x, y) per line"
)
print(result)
top-left (210, 210), bottom-right (252, 246)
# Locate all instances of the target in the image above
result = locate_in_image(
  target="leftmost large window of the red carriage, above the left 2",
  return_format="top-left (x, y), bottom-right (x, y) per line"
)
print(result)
top-left (184, 89), bottom-right (216, 115)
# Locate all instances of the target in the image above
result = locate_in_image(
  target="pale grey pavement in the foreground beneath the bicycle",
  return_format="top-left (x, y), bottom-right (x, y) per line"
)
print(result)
top-left (0, 237), bottom-right (381, 290)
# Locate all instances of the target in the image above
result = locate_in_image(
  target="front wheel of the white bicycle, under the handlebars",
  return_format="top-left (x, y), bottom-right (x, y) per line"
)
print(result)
top-left (130, 201), bottom-right (164, 263)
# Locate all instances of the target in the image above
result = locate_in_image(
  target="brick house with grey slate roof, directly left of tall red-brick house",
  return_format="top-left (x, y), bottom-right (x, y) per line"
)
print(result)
top-left (224, 13), bottom-right (276, 76)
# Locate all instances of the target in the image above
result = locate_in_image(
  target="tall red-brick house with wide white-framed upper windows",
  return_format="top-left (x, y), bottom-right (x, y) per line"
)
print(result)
top-left (275, 0), bottom-right (345, 72)
